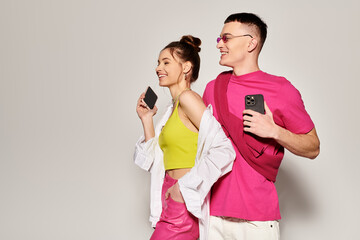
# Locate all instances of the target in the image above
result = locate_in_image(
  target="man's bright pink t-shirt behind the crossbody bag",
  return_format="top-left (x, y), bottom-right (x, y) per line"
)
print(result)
top-left (203, 71), bottom-right (314, 221)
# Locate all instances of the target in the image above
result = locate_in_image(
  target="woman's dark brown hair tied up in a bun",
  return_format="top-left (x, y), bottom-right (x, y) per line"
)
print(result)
top-left (163, 35), bottom-right (201, 82)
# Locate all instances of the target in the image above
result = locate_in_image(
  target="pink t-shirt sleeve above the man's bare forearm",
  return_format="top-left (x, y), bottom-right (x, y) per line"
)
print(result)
top-left (278, 80), bottom-right (314, 134)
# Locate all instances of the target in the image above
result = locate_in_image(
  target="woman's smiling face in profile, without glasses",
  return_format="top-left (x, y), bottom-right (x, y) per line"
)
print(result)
top-left (155, 49), bottom-right (184, 87)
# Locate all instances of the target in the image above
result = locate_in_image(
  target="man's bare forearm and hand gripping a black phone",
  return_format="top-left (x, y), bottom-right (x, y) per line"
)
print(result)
top-left (243, 102), bottom-right (320, 159)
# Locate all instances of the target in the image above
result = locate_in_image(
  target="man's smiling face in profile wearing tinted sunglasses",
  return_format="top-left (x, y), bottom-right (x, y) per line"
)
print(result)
top-left (216, 22), bottom-right (252, 68)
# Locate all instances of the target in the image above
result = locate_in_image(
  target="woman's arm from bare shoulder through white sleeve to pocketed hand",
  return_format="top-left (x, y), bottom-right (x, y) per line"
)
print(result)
top-left (166, 91), bottom-right (236, 218)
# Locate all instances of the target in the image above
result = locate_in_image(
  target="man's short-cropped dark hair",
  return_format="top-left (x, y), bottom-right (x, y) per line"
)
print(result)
top-left (224, 13), bottom-right (267, 50)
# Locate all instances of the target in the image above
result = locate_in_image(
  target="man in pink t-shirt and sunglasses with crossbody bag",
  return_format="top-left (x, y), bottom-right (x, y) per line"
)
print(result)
top-left (201, 13), bottom-right (320, 240)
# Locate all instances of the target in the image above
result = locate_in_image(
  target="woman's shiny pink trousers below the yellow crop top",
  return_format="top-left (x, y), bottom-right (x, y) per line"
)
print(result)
top-left (150, 174), bottom-right (199, 240)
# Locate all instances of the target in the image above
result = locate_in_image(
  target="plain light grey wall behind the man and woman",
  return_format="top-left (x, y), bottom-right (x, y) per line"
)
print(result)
top-left (0, 0), bottom-right (360, 240)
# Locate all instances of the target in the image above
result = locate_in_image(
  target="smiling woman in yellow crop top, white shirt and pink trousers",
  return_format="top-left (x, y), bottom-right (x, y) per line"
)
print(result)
top-left (134, 35), bottom-right (235, 240)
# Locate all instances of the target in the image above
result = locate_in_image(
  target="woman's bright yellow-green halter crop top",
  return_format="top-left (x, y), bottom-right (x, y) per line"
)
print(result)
top-left (159, 102), bottom-right (199, 170)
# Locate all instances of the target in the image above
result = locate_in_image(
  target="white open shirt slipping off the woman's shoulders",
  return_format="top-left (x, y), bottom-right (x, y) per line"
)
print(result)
top-left (134, 104), bottom-right (236, 240)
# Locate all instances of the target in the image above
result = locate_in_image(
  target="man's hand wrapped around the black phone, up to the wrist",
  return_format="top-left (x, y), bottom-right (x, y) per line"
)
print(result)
top-left (243, 102), bottom-right (279, 138)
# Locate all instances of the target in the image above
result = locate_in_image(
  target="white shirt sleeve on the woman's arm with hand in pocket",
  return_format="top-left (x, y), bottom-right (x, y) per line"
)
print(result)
top-left (178, 108), bottom-right (236, 218)
